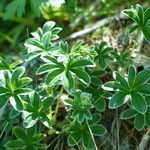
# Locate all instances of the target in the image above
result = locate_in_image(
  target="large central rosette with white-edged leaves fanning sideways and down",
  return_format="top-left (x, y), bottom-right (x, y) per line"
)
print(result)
top-left (36, 53), bottom-right (94, 89)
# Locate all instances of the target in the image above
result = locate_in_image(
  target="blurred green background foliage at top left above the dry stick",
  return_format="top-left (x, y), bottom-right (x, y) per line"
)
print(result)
top-left (0, 0), bottom-right (143, 55)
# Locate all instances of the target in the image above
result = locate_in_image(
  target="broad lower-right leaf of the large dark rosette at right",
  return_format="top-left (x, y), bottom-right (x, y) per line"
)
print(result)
top-left (131, 93), bottom-right (147, 114)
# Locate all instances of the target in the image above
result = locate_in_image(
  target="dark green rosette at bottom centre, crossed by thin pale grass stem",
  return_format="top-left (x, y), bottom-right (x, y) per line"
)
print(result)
top-left (64, 114), bottom-right (107, 149)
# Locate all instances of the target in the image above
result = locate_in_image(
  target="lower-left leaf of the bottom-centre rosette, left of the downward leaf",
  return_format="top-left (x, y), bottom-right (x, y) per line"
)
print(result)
top-left (67, 132), bottom-right (81, 146)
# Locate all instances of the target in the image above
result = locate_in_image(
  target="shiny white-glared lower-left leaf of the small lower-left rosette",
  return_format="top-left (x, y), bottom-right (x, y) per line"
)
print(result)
top-left (23, 114), bottom-right (38, 128)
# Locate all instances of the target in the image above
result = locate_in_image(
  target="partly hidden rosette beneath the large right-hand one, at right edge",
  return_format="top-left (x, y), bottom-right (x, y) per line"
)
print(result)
top-left (121, 96), bottom-right (150, 131)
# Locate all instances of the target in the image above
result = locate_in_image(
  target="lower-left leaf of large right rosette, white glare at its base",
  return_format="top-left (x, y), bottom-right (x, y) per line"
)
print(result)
top-left (109, 91), bottom-right (129, 109)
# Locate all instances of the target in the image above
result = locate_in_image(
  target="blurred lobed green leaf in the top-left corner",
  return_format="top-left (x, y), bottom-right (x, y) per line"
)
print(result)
top-left (4, 0), bottom-right (26, 20)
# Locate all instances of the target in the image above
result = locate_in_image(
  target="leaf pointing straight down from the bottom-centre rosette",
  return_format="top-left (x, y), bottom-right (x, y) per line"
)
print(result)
top-left (82, 132), bottom-right (94, 149)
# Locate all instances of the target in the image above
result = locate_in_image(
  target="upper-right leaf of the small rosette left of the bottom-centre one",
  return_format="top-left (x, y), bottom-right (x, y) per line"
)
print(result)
top-left (40, 97), bottom-right (54, 112)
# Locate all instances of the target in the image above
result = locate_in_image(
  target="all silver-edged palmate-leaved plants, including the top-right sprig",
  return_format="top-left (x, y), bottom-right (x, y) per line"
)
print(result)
top-left (0, 5), bottom-right (150, 150)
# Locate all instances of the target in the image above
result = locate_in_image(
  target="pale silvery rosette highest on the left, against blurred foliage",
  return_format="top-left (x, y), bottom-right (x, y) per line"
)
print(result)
top-left (24, 21), bottom-right (61, 60)
